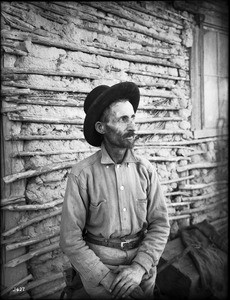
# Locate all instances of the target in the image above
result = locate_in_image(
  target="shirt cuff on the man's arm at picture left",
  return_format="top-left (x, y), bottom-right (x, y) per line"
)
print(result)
top-left (76, 261), bottom-right (110, 286)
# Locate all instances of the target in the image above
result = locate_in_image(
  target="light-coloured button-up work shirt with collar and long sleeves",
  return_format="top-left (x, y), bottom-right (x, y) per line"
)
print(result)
top-left (60, 144), bottom-right (169, 285)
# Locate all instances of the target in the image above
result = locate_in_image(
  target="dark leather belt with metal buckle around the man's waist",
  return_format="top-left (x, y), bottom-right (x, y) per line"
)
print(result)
top-left (84, 232), bottom-right (144, 250)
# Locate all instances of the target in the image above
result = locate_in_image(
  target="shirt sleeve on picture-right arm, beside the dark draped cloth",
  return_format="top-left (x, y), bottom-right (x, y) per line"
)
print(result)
top-left (133, 166), bottom-right (170, 273)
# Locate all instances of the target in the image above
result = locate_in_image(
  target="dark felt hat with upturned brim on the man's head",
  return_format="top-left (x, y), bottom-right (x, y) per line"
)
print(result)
top-left (83, 81), bottom-right (140, 147)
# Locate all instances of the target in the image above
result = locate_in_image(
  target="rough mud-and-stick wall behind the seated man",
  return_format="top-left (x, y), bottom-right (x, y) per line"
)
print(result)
top-left (2, 1), bottom-right (227, 299)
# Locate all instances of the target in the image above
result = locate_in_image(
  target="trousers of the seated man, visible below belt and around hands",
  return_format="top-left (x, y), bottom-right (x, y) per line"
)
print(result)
top-left (81, 242), bottom-right (157, 300)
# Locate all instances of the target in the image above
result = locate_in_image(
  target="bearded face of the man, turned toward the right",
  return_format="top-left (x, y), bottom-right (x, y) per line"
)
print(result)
top-left (104, 101), bottom-right (135, 149)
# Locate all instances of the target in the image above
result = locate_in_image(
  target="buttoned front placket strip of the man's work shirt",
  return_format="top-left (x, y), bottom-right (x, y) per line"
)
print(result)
top-left (115, 164), bottom-right (130, 234)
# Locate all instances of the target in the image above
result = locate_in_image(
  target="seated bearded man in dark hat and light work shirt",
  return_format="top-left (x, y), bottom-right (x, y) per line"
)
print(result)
top-left (60, 82), bottom-right (169, 299)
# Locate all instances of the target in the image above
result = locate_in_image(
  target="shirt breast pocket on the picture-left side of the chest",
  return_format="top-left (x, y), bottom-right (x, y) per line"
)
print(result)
top-left (89, 199), bottom-right (108, 227)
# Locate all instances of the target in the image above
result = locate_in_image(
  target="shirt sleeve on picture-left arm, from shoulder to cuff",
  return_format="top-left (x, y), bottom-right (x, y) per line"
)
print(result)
top-left (60, 173), bottom-right (110, 286)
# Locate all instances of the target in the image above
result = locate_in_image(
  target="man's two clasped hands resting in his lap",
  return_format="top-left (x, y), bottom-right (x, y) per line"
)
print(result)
top-left (101, 262), bottom-right (145, 299)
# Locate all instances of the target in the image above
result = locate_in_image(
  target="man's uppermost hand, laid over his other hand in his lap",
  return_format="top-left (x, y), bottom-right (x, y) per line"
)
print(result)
top-left (110, 263), bottom-right (145, 299)
